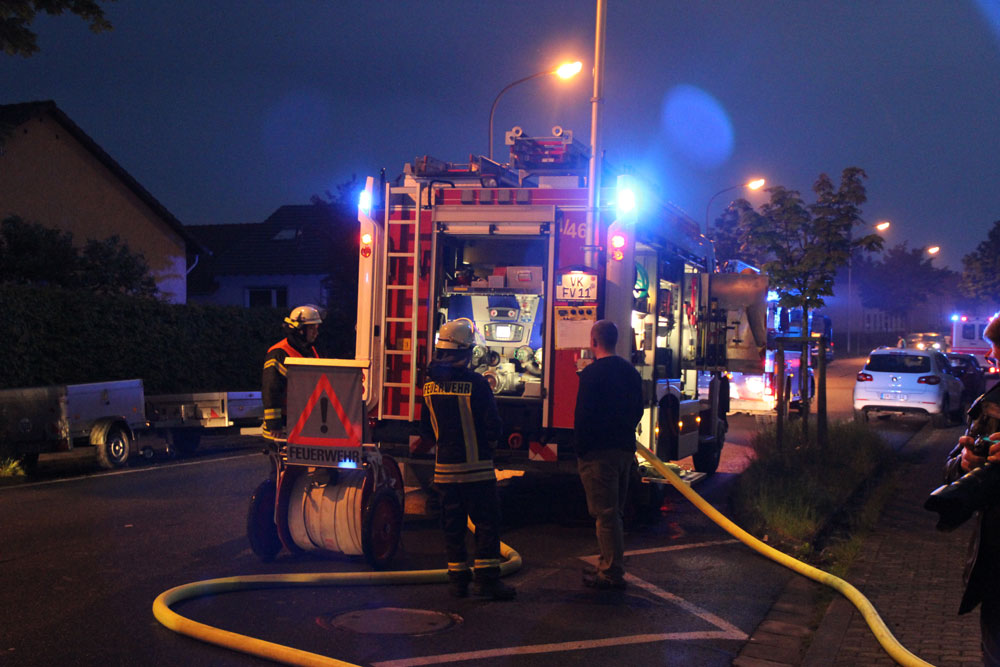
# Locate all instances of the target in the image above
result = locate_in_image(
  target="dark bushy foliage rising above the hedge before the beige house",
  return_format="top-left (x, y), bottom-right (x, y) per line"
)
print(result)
top-left (0, 216), bottom-right (158, 297)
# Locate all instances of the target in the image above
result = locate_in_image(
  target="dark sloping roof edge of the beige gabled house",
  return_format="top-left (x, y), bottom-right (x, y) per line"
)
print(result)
top-left (0, 100), bottom-right (204, 251)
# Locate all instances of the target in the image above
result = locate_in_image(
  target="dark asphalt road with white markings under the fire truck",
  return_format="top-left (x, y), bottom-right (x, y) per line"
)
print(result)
top-left (0, 360), bottom-right (922, 667)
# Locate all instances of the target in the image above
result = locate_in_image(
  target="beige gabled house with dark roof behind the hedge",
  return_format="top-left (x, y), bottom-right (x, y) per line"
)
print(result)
top-left (0, 101), bottom-right (201, 303)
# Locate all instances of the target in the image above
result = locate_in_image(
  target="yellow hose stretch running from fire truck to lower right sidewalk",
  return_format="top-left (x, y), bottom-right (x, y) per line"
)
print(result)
top-left (636, 443), bottom-right (930, 667)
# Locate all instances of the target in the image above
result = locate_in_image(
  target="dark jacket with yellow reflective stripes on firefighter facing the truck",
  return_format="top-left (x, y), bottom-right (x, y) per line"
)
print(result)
top-left (420, 362), bottom-right (503, 484)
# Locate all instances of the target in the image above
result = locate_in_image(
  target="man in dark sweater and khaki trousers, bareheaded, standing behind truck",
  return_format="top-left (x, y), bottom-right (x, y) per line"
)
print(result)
top-left (573, 320), bottom-right (643, 590)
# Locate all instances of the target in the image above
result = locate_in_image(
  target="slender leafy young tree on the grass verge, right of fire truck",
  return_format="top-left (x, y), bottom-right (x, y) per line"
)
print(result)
top-left (739, 167), bottom-right (882, 428)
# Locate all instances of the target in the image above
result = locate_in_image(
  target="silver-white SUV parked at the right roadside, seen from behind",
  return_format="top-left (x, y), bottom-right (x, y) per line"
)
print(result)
top-left (854, 347), bottom-right (965, 428)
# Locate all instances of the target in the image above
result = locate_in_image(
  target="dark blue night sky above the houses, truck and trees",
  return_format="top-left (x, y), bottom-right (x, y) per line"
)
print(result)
top-left (7, 0), bottom-right (1000, 269)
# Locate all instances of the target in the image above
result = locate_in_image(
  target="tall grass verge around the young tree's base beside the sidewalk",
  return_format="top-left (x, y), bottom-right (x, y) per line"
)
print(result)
top-left (732, 421), bottom-right (894, 576)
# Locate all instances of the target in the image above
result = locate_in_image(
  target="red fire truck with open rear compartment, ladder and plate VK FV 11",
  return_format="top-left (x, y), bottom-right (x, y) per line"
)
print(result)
top-left (356, 127), bottom-right (744, 494)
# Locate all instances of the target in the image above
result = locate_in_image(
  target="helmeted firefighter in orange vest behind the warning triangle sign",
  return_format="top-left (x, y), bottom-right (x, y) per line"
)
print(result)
top-left (261, 304), bottom-right (323, 440)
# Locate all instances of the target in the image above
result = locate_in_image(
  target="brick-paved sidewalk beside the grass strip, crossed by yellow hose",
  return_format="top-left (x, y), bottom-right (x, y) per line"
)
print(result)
top-left (733, 427), bottom-right (982, 667)
